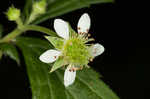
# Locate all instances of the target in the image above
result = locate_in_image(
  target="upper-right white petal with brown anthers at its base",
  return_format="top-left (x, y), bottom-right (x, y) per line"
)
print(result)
top-left (77, 13), bottom-right (91, 34)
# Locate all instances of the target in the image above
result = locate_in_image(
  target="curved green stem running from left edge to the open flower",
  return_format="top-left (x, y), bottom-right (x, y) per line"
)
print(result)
top-left (0, 25), bottom-right (57, 43)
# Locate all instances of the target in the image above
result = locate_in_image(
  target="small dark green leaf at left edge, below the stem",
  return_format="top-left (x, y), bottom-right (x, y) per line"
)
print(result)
top-left (0, 43), bottom-right (20, 65)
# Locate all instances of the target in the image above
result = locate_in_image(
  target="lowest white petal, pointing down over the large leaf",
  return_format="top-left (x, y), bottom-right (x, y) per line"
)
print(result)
top-left (64, 67), bottom-right (76, 87)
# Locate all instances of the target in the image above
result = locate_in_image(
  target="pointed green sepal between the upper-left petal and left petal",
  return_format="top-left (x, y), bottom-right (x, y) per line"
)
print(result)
top-left (45, 36), bottom-right (64, 50)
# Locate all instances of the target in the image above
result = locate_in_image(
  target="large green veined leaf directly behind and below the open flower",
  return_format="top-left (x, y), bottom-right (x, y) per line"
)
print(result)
top-left (16, 37), bottom-right (119, 99)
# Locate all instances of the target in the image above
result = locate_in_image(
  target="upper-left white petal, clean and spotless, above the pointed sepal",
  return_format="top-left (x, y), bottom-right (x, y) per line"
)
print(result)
top-left (54, 19), bottom-right (69, 39)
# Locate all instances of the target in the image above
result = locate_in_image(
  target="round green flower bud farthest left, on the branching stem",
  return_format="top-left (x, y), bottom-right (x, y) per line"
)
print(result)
top-left (6, 6), bottom-right (20, 21)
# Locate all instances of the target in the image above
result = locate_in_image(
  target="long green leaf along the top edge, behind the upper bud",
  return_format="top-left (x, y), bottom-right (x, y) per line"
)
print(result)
top-left (24, 0), bottom-right (113, 24)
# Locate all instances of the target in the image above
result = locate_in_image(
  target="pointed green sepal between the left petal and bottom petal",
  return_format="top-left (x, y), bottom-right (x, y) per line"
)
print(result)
top-left (50, 57), bottom-right (65, 72)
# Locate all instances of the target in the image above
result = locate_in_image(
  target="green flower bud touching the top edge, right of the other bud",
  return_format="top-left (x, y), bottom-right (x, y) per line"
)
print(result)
top-left (33, 0), bottom-right (46, 14)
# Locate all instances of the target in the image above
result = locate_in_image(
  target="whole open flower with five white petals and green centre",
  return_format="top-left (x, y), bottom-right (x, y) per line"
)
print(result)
top-left (40, 13), bottom-right (104, 87)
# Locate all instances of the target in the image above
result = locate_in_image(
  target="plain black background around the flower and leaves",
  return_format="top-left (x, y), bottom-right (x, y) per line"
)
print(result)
top-left (0, 0), bottom-right (150, 99)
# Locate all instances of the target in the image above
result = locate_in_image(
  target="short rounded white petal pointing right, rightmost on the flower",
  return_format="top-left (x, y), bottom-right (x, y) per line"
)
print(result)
top-left (91, 43), bottom-right (105, 57)
